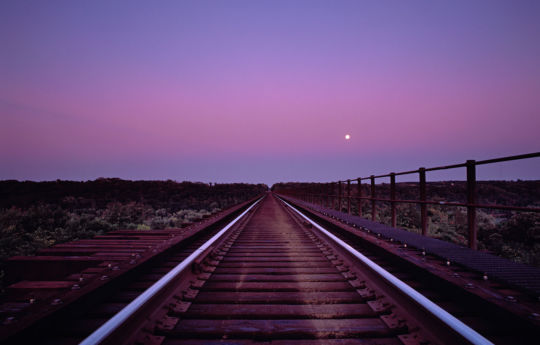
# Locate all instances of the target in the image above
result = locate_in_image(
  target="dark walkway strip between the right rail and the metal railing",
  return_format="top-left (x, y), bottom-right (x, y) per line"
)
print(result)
top-left (278, 195), bottom-right (540, 344)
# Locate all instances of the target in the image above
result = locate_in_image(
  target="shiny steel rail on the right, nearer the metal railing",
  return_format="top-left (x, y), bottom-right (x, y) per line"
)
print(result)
top-left (278, 197), bottom-right (493, 345)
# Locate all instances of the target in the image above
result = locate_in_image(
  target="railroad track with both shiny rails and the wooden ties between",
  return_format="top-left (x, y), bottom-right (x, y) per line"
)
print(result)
top-left (81, 197), bottom-right (490, 345)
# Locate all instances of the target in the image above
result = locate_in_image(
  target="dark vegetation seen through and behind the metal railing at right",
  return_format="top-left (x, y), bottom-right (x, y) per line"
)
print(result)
top-left (272, 180), bottom-right (540, 267)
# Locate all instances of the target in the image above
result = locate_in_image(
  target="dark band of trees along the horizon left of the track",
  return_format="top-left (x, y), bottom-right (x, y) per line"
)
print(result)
top-left (0, 178), bottom-right (267, 212)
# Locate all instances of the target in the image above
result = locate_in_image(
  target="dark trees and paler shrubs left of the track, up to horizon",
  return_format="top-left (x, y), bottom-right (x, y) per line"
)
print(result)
top-left (0, 178), bottom-right (268, 259)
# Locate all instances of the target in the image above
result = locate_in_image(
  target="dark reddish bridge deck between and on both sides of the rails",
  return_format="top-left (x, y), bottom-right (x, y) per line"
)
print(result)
top-left (0, 194), bottom-right (540, 345)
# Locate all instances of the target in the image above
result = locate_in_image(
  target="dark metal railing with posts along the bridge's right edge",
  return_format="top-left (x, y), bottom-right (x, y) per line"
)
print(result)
top-left (279, 152), bottom-right (540, 249)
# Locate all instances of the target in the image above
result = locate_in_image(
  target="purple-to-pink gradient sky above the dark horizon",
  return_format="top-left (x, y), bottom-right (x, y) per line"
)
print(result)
top-left (0, 0), bottom-right (540, 184)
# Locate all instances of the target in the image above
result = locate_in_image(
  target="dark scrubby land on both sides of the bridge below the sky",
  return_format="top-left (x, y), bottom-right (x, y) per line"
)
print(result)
top-left (0, 179), bottom-right (540, 284)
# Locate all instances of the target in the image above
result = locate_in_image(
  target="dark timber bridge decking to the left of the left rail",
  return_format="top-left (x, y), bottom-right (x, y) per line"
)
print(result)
top-left (0, 199), bottom-right (262, 344)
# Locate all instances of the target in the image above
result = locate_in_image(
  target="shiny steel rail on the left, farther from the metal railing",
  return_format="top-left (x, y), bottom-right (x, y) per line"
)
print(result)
top-left (79, 198), bottom-right (262, 345)
